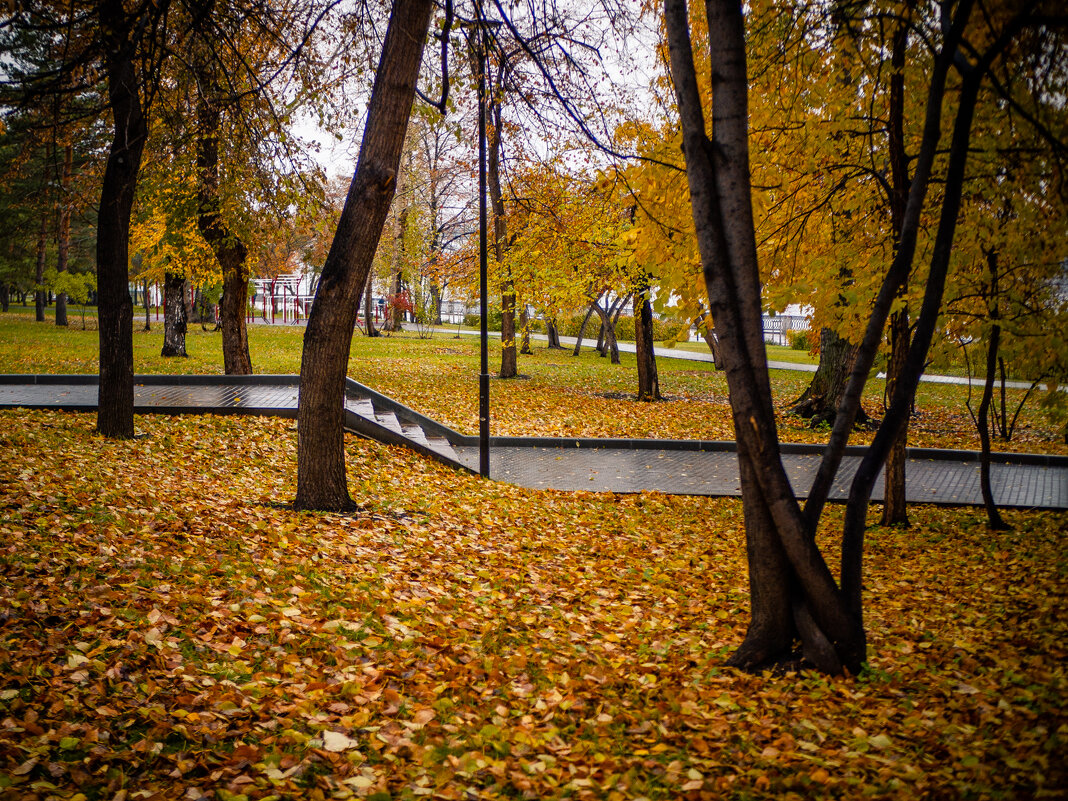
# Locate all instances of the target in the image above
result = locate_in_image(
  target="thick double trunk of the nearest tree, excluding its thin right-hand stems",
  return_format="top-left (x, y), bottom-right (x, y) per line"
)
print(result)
top-left (664, 0), bottom-right (865, 673)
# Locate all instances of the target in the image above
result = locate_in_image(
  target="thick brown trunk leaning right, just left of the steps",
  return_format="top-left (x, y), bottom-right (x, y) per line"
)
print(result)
top-left (296, 0), bottom-right (433, 509)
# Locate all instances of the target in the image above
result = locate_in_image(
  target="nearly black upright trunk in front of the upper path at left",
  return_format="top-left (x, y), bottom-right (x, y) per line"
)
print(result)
top-left (96, 0), bottom-right (148, 439)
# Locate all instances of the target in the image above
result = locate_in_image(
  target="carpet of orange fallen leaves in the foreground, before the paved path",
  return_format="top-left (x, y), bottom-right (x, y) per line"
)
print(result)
top-left (0, 410), bottom-right (1068, 801)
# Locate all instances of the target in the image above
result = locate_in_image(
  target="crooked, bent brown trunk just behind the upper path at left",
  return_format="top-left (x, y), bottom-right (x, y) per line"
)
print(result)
top-left (197, 64), bottom-right (252, 376)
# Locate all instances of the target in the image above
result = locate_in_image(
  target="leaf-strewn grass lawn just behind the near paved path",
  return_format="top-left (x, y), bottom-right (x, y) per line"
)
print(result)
top-left (0, 314), bottom-right (1068, 453)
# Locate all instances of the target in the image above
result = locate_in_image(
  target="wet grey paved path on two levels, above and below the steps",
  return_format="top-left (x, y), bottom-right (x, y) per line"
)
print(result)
top-left (0, 376), bottom-right (1068, 509)
